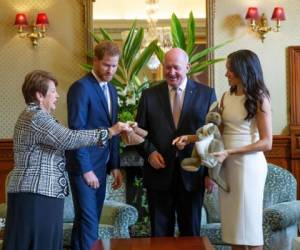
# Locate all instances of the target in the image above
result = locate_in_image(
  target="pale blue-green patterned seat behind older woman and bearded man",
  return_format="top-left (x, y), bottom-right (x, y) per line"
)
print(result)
top-left (0, 171), bottom-right (138, 249)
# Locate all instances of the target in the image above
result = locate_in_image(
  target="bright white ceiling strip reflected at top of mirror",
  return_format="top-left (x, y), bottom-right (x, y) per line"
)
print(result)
top-left (93, 0), bottom-right (206, 20)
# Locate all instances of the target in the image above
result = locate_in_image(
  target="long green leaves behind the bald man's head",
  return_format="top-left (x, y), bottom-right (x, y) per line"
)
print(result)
top-left (155, 12), bottom-right (231, 75)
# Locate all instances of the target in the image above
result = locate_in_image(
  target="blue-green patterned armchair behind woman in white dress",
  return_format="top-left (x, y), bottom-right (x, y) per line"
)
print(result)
top-left (201, 164), bottom-right (300, 250)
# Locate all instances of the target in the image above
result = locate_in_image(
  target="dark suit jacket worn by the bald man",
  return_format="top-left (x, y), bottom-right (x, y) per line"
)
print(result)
top-left (136, 80), bottom-right (216, 191)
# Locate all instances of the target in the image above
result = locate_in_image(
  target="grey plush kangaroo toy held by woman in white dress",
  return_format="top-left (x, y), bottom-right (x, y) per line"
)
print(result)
top-left (181, 102), bottom-right (229, 192)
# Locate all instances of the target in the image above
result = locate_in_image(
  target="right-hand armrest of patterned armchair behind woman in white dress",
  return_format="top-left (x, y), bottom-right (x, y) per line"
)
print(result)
top-left (263, 200), bottom-right (300, 231)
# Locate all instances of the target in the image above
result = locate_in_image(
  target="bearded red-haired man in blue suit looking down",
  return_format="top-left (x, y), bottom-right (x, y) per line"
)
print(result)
top-left (67, 41), bottom-right (122, 250)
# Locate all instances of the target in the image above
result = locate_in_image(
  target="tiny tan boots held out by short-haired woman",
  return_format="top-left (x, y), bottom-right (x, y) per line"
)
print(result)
top-left (121, 121), bottom-right (148, 146)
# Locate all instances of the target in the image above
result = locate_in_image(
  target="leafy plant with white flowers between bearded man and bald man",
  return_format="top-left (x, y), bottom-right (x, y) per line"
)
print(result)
top-left (83, 22), bottom-right (157, 121)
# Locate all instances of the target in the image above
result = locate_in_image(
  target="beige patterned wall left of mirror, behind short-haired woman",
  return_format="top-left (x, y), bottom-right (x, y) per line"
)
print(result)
top-left (0, 0), bottom-right (86, 139)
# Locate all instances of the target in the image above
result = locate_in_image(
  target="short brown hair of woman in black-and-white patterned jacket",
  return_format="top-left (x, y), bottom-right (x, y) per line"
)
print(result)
top-left (22, 70), bottom-right (58, 104)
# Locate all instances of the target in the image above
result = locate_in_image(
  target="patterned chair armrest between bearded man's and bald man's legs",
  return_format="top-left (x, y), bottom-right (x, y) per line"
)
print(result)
top-left (100, 201), bottom-right (138, 238)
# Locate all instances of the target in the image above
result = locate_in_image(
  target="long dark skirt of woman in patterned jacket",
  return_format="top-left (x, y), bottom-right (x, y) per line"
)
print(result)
top-left (3, 193), bottom-right (64, 250)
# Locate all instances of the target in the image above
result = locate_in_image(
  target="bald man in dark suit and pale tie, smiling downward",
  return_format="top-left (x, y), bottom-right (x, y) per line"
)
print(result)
top-left (136, 48), bottom-right (216, 236)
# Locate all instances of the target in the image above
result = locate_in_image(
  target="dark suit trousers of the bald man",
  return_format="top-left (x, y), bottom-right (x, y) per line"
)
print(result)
top-left (147, 163), bottom-right (204, 237)
